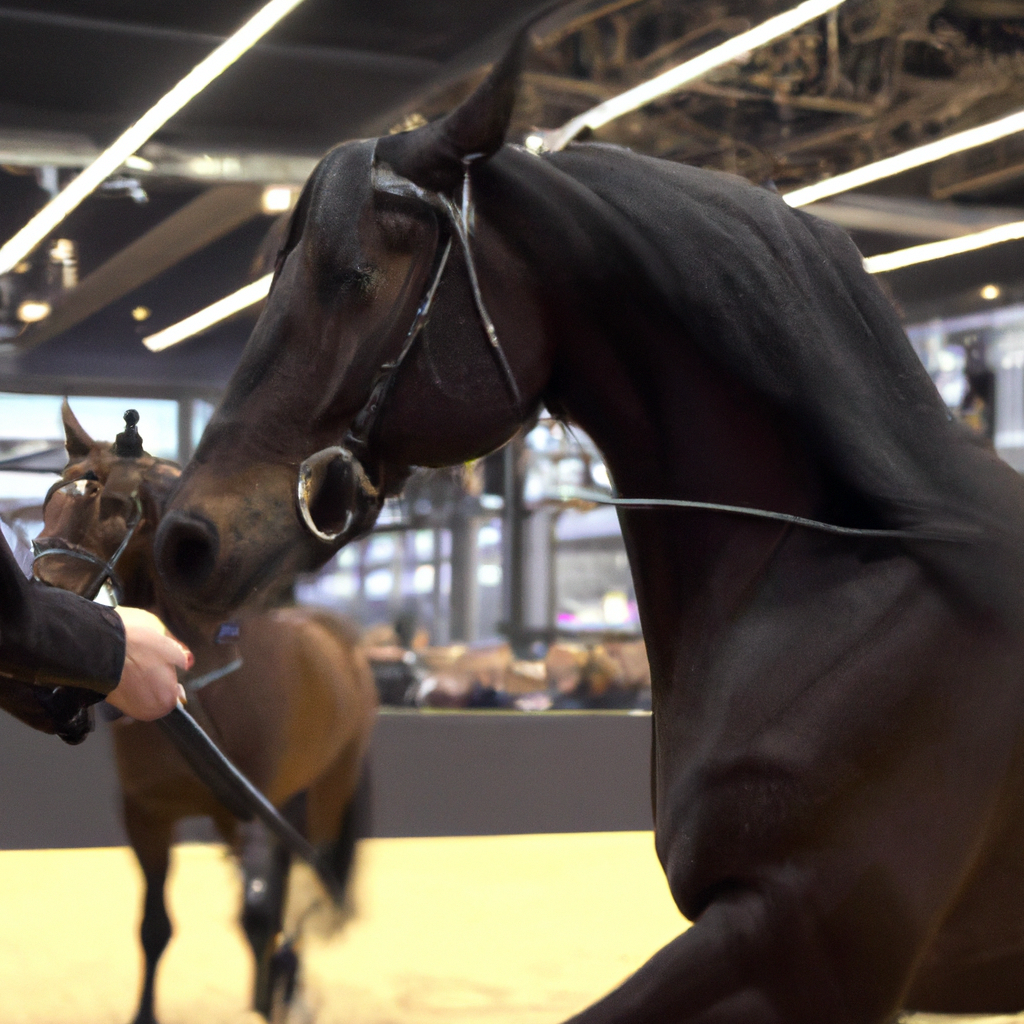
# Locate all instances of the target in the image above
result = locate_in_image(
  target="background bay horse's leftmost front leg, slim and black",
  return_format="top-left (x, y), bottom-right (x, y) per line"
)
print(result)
top-left (124, 798), bottom-right (172, 1024)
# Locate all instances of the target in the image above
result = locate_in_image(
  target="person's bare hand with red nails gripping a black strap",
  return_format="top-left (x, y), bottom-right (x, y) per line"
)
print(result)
top-left (106, 607), bottom-right (195, 722)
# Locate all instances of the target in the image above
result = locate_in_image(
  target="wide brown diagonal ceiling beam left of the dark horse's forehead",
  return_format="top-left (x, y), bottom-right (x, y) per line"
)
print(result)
top-left (14, 184), bottom-right (263, 352)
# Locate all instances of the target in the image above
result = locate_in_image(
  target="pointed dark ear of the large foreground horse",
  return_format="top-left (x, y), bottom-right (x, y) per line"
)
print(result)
top-left (377, 4), bottom-right (548, 191)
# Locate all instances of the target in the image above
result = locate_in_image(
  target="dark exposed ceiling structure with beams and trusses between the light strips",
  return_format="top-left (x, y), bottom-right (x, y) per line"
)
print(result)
top-left (0, 0), bottom-right (1024, 394)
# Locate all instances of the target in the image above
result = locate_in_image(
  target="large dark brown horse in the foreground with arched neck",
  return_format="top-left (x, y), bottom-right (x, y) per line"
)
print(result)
top-left (157, 16), bottom-right (1024, 1024)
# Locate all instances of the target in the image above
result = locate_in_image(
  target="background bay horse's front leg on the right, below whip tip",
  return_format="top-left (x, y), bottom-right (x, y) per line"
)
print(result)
top-left (241, 821), bottom-right (297, 1020)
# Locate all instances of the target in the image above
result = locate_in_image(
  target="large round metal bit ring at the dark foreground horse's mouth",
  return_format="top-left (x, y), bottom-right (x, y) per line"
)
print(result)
top-left (296, 446), bottom-right (384, 546)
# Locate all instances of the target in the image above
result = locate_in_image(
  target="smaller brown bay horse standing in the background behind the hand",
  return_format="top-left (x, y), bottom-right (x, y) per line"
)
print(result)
top-left (35, 402), bottom-right (377, 1024)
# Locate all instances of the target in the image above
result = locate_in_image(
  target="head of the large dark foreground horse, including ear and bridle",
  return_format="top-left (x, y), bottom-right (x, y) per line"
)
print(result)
top-left (157, 16), bottom-right (552, 612)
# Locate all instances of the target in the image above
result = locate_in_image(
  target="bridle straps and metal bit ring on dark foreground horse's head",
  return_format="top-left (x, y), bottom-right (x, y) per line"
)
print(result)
top-left (296, 155), bottom-right (522, 544)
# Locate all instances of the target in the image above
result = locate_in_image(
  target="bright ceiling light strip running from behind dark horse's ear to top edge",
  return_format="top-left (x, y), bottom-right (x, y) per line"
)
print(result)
top-left (542, 0), bottom-right (843, 151)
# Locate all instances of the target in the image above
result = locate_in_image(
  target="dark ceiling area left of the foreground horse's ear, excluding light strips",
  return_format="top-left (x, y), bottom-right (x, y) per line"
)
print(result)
top-left (0, 0), bottom-right (537, 394)
